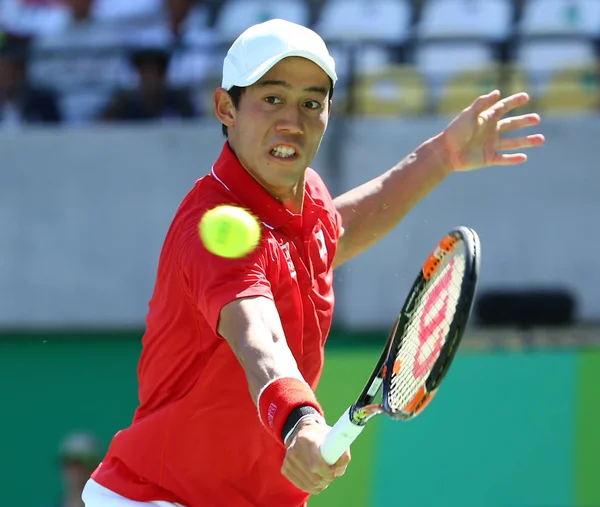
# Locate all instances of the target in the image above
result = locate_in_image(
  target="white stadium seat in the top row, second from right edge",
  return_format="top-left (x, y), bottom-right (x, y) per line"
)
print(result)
top-left (417, 0), bottom-right (513, 41)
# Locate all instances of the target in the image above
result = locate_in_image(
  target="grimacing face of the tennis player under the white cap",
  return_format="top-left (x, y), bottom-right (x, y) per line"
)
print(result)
top-left (224, 57), bottom-right (331, 195)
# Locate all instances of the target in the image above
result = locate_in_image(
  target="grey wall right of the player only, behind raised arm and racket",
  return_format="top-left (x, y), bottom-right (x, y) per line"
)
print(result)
top-left (338, 116), bottom-right (600, 326)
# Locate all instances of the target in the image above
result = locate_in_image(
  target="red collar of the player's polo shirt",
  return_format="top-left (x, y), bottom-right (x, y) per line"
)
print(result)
top-left (211, 142), bottom-right (314, 229)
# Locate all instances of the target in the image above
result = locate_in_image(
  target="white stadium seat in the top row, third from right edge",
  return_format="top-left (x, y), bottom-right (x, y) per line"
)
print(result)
top-left (315, 0), bottom-right (412, 44)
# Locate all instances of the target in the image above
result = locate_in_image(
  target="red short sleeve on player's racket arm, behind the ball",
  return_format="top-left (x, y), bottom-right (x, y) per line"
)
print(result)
top-left (178, 204), bottom-right (273, 334)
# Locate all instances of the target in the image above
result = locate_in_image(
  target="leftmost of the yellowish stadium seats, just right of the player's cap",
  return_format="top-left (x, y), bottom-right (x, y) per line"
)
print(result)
top-left (352, 65), bottom-right (428, 116)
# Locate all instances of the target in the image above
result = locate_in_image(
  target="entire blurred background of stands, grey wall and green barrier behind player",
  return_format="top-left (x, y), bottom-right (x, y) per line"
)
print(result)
top-left (0, 0), bottom-right (600, 507)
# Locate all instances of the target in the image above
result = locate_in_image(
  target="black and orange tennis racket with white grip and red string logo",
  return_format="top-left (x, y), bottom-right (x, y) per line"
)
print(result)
top-left (321, 227), bottom-right (480, 465)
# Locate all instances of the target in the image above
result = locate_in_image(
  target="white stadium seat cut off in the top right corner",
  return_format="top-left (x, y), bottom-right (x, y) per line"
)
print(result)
top-left (518, 0), bottom-right (600, 37)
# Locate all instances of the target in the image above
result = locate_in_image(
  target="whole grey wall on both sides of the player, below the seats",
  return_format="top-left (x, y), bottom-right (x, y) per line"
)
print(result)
top-left (0, 120), bottom-right (600, 327)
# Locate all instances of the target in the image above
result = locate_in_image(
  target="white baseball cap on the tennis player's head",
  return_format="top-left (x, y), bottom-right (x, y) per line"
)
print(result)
top-left (221, 19), bottom-right (337, 90)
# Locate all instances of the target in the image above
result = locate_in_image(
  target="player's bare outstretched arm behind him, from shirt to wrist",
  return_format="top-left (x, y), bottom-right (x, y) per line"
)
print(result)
top-left (334, 136), bottom-right (450, 267)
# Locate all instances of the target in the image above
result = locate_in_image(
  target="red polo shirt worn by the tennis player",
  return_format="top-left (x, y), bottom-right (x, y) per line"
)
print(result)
top-left (92, 143), bottom-right (341, 507)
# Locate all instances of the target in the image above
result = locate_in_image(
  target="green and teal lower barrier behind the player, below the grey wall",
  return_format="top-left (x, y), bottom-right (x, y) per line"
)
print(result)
top-left (0, 332), bottom-right (600, 507)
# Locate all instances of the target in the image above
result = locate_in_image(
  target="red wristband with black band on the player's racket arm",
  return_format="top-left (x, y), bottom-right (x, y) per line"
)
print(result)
top-left (257, 377), bottom-right (323, 442)
